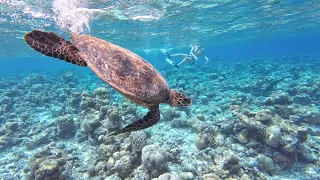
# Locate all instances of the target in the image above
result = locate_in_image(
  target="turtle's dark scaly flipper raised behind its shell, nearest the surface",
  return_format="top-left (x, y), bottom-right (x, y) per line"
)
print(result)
top-left (24, 30), bottom-right (87, 66)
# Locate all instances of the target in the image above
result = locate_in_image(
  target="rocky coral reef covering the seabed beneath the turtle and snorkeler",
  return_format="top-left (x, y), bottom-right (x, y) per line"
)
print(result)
top-left (0, 56), bottom-right (320, 180)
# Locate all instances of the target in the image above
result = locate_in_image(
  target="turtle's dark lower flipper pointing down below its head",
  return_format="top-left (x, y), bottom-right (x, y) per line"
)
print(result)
top-left (109, 105), bottom-right (160, 136)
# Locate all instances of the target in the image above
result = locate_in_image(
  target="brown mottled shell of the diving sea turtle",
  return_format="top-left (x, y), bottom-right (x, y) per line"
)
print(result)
top-left (71, 34), bottom-right (169, 107)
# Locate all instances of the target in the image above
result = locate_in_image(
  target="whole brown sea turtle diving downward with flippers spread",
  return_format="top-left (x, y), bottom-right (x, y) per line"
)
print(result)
top-left (24, 30), bottom-right (192, 135)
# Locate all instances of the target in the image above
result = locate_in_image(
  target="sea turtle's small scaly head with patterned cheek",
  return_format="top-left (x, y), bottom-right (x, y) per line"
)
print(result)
top-left (168, 90), bottom-right (192, 106)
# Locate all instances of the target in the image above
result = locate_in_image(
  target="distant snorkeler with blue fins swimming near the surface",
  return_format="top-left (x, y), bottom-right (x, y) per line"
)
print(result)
top-left (165, 46), bottom-right (209, 68)
